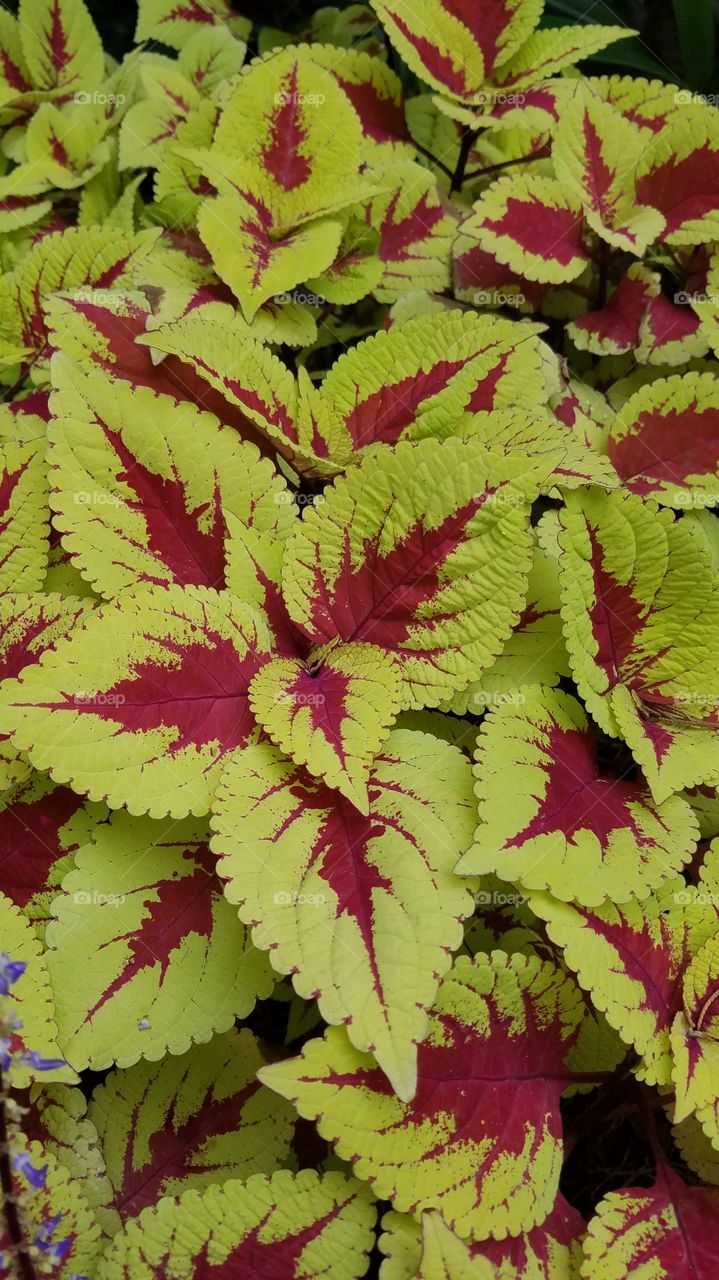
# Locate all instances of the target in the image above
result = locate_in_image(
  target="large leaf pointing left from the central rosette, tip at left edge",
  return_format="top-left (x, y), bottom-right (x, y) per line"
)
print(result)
top-left (0, 586), bottom-right (270, 818)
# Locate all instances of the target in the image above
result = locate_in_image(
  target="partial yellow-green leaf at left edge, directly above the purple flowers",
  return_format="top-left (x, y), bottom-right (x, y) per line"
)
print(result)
top-left (0, 893), bottom-right (77, 1089)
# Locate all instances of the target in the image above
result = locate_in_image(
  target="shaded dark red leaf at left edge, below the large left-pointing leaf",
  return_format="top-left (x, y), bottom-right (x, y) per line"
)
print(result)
top-left (0, 773), bottom-right (107, 922)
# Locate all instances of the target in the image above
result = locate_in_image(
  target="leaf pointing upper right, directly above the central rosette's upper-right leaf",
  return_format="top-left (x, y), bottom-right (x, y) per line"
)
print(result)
top-left (316, 311), bottom-right (536, 451)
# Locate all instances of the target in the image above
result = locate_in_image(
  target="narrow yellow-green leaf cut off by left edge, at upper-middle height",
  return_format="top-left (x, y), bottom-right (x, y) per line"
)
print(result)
top-left (0, 410), bottom-right (50, 591)
